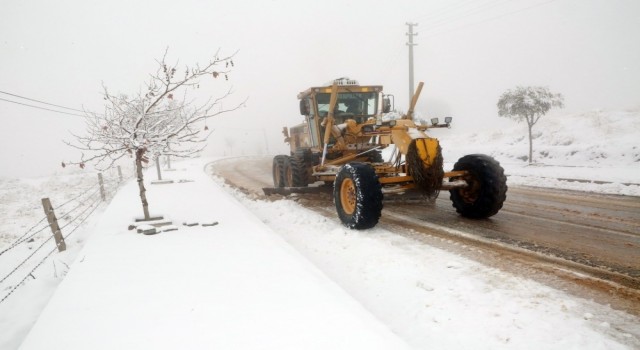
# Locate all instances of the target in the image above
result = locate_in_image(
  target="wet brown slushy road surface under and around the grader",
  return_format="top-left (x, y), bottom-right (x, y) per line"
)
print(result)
top-left (210, 157), bottom-right (640, 315)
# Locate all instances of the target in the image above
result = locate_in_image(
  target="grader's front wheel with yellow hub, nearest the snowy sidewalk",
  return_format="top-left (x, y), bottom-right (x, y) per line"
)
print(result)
top-left (333, 163), bottom-right (383, 230)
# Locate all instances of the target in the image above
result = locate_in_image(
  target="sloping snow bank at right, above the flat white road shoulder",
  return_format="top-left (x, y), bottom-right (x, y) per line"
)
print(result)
top-left (437, 110), bottom-right (640, 167)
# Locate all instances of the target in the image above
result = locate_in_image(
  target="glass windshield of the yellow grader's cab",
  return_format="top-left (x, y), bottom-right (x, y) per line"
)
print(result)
top-left (316, 92), bottom-right (378, 117)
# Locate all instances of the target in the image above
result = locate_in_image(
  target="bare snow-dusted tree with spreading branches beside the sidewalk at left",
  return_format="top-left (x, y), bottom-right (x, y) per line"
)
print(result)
top-left (63, 51), bottom-right (244, 220)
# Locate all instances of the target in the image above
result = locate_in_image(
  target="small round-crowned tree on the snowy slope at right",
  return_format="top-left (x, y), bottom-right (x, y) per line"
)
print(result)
top-left (498, 86), bottom-right (564, 164)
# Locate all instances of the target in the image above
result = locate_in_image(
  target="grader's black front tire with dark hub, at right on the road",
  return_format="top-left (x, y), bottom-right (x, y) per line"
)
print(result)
top-left (449, 154), bottom-right (507, 219)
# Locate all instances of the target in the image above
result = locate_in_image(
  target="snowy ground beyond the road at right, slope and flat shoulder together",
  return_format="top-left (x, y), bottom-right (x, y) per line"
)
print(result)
top-left (434, 109), bottom-right (640, 196)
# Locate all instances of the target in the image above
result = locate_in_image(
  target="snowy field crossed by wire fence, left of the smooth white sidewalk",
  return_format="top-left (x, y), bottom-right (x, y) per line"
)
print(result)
top-left (0, 166), bottom-right (130, 349)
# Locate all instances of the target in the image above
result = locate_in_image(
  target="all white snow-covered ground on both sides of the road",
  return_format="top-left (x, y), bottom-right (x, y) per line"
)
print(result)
top-left (0, 108), bottom-right (640, 349)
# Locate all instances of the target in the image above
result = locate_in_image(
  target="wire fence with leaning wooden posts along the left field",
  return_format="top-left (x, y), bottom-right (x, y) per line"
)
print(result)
top-left (0, 170), bottom-right (133, 303)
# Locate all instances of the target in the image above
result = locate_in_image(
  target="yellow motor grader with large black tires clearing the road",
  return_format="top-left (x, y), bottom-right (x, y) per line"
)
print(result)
top-left (263, 78), bottom-right (507, 229)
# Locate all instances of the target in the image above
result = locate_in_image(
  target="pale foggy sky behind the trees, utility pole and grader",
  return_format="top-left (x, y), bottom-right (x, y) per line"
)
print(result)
top-left (0, 0), bottom-right (640, 177)
